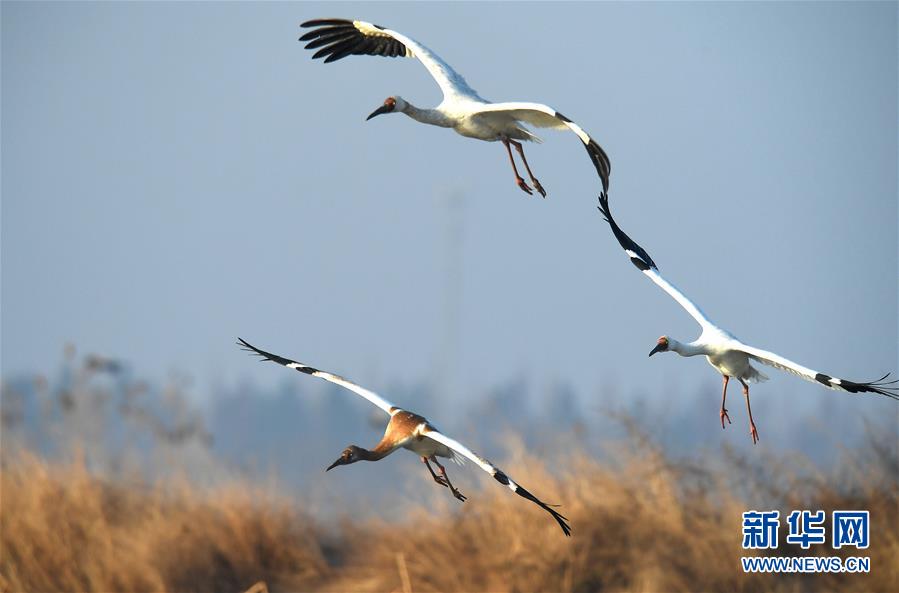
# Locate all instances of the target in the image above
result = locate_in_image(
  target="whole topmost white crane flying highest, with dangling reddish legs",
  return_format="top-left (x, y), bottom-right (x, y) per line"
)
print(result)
top-left (300, 19), bottom-right (611, 197)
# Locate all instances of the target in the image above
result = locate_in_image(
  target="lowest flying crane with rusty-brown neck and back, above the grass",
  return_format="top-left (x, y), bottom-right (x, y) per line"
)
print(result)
top-left (237, 338), bottom-right (571, 535)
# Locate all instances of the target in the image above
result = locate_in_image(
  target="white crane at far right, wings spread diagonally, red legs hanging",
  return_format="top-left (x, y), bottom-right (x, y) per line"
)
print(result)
top-left (599, 192), bottom-right (899, 443)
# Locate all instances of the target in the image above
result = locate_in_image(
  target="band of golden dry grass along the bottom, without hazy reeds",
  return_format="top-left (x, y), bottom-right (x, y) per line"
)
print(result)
top-left (0, 426), bottom-right (899, 593)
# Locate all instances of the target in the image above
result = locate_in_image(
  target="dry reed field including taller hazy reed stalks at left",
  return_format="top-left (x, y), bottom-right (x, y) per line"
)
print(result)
top-left (0, 352), bottom-right (899, 593)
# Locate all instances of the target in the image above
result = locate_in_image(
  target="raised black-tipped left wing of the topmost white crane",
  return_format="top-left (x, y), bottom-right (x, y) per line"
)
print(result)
top-left (300, 19), bottom-right (482, 100)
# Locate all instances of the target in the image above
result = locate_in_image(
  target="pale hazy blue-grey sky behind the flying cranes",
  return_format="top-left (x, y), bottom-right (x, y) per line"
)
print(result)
top-left (0, 2), bottom-right (899, 442)
